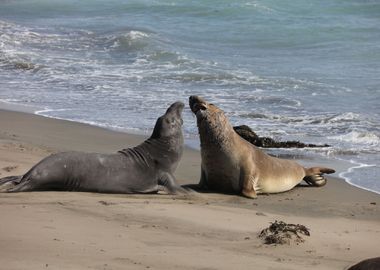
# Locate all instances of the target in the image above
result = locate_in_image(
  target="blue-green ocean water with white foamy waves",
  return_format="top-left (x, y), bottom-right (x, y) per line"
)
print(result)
top-left (0, 0), bottom-right (380, 193)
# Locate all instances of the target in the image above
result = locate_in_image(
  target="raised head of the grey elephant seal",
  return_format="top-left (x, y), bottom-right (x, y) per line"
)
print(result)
top-left (151, 101), bottom-right (185, 139)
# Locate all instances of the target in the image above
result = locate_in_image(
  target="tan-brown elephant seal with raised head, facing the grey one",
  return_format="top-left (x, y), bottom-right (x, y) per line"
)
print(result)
top-left (189, 96), bottom-right (335, 198)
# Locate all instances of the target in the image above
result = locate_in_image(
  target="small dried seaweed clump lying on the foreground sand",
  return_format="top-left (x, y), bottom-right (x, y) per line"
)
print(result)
top-left (259, 220), bottom-right (310, 245)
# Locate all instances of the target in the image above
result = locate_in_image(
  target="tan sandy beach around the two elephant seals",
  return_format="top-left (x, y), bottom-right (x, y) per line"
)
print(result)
top-left (0, 110), bottom-right (380, 269)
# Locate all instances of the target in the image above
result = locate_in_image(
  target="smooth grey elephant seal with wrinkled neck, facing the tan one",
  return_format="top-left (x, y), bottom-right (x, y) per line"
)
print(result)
top-left (0, 102), bottom-right (184, 193)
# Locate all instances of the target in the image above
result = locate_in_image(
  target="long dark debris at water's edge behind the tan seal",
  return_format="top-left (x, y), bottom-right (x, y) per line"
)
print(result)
top-left (234, 125), bottom-right (330, 148)
